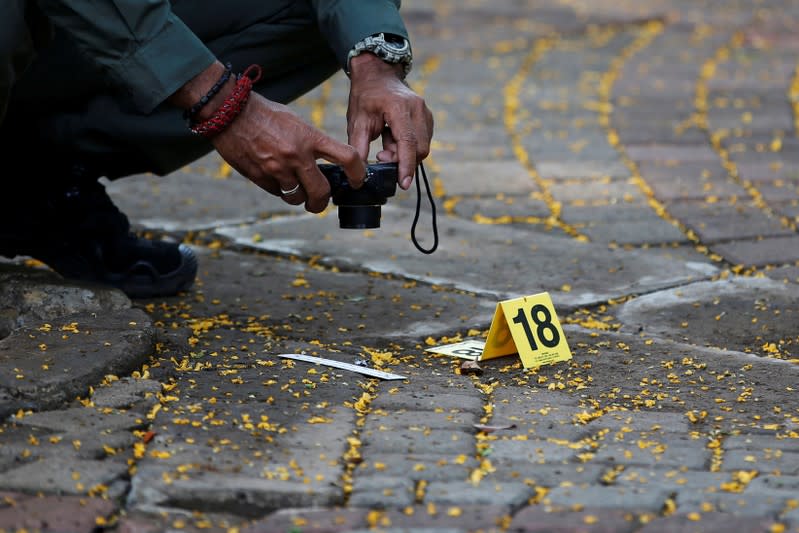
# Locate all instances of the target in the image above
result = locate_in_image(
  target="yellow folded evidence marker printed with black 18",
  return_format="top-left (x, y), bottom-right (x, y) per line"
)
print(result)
top-left (478, 292), bottom-right (572, 368)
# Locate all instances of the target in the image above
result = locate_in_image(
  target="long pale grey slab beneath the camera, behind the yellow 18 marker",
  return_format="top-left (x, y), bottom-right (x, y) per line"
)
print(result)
top-left (212, 206), bottom-right (717, 307)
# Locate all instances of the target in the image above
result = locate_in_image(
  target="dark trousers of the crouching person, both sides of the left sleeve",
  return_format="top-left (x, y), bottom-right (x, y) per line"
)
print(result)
top-left (3, 0), bottom-right (340, 179)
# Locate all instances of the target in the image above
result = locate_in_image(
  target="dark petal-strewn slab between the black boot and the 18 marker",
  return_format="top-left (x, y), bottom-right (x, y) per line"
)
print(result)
top-left (161, 246), bottom-right (496, 340)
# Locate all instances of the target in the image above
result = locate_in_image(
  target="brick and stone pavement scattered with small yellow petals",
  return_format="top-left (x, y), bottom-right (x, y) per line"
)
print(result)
top-left (0, 0), bottom-right (799, 533)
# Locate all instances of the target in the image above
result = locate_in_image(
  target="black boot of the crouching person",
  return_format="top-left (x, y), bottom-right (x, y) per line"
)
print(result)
top-left (0, 166), bottom-right (197, 298)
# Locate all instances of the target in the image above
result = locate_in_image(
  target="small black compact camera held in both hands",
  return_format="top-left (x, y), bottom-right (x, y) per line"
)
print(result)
top-left (319, 163), bottom-right (398, 229)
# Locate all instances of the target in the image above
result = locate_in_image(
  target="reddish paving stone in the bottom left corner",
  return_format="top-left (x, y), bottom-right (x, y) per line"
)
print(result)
top-left (0, 493), bottom-right (116, 533)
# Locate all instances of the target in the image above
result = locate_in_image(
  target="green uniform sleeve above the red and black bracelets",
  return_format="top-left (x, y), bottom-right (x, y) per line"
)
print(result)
top-left (39, 0), bottom-right (214, 112)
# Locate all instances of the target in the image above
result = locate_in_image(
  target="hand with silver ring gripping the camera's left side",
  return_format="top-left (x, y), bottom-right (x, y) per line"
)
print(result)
top-left (212, 91), bottom-right (366, 213)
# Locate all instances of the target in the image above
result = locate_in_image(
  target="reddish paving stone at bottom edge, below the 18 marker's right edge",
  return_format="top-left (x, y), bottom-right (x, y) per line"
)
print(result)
top-left (508, 506), bottom-right (639, 533)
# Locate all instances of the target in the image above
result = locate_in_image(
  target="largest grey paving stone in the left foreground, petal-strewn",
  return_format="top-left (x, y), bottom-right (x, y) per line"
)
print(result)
top-left (128, 400), bottom-right (354, 518)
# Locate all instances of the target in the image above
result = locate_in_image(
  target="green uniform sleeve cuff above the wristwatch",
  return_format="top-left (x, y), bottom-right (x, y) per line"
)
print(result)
top-left (311, 0), bottom-right (408, 67)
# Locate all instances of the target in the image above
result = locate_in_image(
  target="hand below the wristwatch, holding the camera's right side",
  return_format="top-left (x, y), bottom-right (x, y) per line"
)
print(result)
top-left (347, 53), bottom-right (433, 189)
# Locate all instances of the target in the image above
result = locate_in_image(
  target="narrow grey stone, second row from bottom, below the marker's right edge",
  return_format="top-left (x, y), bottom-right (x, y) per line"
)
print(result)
top-left (541, 485), bottom-right (669, 513)
